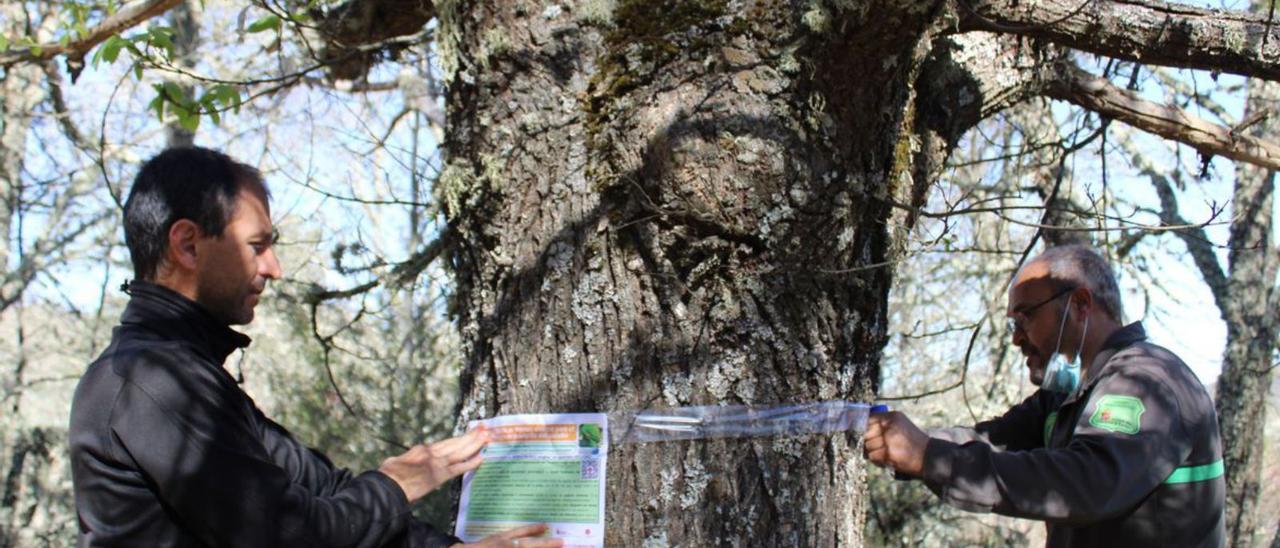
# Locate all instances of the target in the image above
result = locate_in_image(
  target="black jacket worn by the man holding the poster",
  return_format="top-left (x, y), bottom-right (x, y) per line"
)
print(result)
top-left (69, 282), bottom-right (457, 547)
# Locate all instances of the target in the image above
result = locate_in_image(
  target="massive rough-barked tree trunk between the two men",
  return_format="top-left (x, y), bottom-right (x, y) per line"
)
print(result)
top-left (438, 0), bottom-right (929, 545)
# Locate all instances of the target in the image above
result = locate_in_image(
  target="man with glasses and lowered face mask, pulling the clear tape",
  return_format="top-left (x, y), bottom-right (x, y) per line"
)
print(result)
top-left (864, 246), bottom-right (1225, 548)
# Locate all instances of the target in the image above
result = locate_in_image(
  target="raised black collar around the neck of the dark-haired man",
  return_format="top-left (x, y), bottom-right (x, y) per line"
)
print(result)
top-left (120, 280), bottom-right (251, 364)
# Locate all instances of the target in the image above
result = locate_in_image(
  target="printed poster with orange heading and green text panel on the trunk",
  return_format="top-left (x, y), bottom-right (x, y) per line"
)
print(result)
top-left (454, 414), bottom-right (609, 548)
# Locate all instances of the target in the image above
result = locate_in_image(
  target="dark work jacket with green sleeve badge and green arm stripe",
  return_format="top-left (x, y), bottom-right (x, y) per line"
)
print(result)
top-left (924, 323), bottom-right (1225, 548)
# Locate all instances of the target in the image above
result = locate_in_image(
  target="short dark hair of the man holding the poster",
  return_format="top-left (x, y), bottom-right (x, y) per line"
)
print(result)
top-left (124, 146), bottom-right (271, 280)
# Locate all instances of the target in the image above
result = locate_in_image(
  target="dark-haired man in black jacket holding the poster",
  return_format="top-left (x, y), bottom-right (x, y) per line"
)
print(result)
top-left (69, 147), bottom-right (561, 547)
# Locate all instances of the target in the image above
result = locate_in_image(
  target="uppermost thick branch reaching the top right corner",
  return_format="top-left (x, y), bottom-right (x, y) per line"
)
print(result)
top-left (956, 0), bottom-right (1280, 81)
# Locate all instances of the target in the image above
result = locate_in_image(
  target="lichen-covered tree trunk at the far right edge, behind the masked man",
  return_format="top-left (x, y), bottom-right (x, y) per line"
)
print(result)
top-left (1216, 62), bottom-right (1280, 547)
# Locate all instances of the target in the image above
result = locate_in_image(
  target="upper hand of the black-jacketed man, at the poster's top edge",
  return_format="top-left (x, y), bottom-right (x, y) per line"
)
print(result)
top-left (378, 425), bottom-right (489, 504)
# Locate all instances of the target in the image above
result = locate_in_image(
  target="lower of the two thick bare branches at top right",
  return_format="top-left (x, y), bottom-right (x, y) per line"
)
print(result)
top-left (1044, 63), bottom-right (1280, 169)
